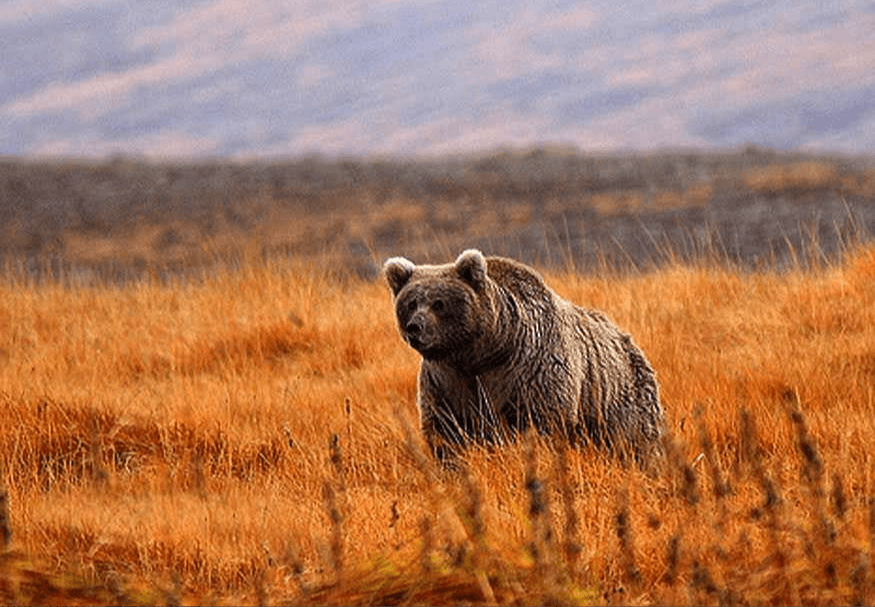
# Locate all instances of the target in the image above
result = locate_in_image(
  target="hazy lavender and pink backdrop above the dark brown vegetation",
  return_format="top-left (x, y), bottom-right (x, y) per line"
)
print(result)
top-left (0, 0), bottom-right (875, 159)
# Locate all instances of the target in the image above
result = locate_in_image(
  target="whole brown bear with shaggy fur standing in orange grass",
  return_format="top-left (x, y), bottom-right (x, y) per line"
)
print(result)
top-left (384, 250), bottom-right (663, 461)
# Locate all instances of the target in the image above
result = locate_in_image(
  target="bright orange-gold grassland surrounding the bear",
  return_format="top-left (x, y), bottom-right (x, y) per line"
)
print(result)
top-left (0, 246), bottom-right (875, 605)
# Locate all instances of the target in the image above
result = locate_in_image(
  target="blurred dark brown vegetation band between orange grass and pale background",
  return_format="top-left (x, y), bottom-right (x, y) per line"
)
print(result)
top-left (0, 148), bottom-right (875, 280)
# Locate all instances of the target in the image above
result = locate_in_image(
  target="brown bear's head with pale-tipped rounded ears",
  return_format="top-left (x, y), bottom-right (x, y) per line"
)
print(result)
top-left (383, 249), bottom-right (496, 361)
